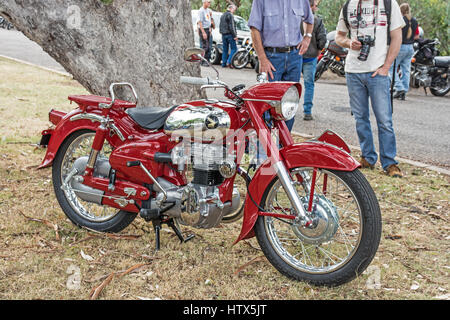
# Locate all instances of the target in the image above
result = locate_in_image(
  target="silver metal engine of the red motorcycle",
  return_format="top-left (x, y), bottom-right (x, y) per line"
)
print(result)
top-left (158, 142), bottom-right (241, 228)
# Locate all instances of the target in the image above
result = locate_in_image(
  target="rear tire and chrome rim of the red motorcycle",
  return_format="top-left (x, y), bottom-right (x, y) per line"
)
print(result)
top-left (52, 130), bottom-right (137, 232)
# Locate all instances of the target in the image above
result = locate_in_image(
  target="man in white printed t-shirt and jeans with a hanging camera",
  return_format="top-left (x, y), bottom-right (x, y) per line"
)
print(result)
top-left (336, 0), bottom-right (405, 177)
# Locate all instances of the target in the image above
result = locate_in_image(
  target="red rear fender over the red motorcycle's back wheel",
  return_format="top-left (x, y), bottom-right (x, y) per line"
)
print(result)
top-left (38, 109), bottom-right (99, 169)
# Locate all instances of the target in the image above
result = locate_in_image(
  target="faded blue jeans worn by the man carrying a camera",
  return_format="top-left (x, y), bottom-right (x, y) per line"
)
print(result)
top-left (346, 72), bottom-right (398, 170)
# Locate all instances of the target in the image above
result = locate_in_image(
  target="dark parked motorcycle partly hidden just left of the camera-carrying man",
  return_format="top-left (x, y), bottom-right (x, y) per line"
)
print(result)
top-left (314, 31), bottom-right (348, 81)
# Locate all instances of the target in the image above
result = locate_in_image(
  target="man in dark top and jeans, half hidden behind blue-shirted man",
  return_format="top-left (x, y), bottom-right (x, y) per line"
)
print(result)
top-left (301, 0), bottom-right (327, 120)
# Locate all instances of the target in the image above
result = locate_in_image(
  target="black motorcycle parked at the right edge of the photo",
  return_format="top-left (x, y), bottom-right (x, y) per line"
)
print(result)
top-left (410, 39), bottom-right (450, 97)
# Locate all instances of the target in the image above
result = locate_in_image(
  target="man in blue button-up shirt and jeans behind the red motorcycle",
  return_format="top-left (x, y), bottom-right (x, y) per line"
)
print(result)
top-left (248, 0), bottom-right (314, 130)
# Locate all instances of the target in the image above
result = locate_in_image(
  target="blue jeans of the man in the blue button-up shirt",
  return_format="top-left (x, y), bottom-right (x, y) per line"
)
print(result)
top-left (266, 49), bottom-right (303, 131)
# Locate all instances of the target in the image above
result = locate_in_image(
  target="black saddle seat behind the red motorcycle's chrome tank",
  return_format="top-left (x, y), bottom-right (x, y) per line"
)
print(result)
top-left (126, 106), bottom-right (177, 130)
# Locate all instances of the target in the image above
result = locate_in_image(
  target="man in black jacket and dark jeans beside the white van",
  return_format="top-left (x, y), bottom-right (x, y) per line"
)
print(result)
top-left (219, 4), bottom-right (237, 68)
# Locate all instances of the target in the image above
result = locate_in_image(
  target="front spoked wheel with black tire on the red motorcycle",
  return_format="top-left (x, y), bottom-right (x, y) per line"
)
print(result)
top-left (255, 168), bottom-right (381, 286)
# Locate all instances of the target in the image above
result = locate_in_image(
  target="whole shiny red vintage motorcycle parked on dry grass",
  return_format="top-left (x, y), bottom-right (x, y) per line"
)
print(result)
top-left (40, 48), bottom-right (381, 286)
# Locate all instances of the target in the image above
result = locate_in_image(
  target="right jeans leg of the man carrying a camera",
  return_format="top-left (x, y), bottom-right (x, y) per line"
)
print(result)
top-left (368, 75), bottom-right (398, 170)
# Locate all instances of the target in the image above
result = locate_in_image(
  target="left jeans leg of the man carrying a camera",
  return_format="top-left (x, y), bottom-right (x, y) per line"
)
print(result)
top-left (346, 73), bottom-right (378, 165)
